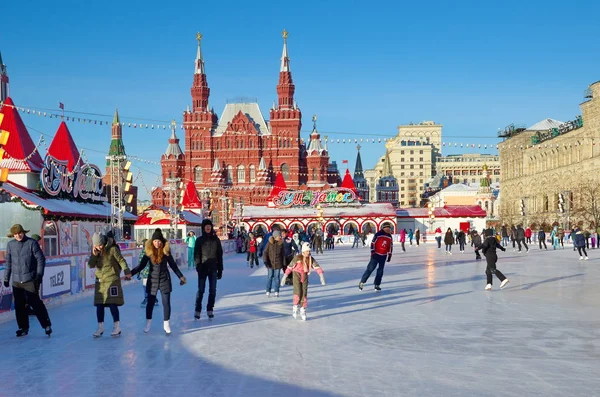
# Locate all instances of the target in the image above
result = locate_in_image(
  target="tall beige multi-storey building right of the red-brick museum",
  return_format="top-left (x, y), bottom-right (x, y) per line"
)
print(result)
top-left (365, 121), bottom-right (442, 207)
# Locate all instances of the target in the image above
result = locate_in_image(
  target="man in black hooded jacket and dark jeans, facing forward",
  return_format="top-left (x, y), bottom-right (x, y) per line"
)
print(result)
top-left (194, 219), bottom-right (223, 320)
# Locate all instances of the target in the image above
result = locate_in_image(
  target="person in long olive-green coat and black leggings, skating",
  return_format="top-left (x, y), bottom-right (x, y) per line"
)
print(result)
top-left (88, 233), bottom-right (131, 338)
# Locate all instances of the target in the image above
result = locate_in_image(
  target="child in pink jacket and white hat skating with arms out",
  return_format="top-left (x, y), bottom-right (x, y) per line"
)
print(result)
top-left (281, 243), bottom-right (325, 321)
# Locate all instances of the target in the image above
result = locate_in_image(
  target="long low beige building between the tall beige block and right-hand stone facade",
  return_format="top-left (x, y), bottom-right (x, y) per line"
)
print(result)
top-left (435, 153), bottom-right (500, 185)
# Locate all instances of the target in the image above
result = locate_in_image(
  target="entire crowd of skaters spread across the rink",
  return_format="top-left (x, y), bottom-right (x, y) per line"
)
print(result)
top-left (4, 219), bottom-right (600, 338)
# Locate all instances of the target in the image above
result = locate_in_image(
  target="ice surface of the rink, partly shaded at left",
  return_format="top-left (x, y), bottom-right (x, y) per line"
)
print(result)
top-left (0, 240), bottom-right (600, 397)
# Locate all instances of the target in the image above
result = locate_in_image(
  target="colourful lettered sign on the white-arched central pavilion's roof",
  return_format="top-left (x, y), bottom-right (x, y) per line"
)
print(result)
top-left (273, 188), bottom-right (358, 208)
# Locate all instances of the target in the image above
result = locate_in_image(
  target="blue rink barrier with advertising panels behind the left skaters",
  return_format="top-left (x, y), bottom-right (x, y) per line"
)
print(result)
top-left (0, 240), bottom-right (236, 323)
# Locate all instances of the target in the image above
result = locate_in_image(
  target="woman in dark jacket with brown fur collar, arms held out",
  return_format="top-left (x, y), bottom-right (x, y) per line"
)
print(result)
top-left (131, 229), bottom-right (187, 335)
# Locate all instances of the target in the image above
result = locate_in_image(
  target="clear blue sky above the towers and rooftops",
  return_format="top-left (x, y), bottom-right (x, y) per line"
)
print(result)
top-left (0, 0), bottom-right (600, 198)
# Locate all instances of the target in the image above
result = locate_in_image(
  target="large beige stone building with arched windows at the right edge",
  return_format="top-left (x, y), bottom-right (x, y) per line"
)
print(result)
top-left (498, 82), bottom-right (600, 228)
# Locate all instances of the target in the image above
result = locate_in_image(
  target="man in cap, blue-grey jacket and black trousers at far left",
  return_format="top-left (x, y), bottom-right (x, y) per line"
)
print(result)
top-left (4, 224), bottom-right (52, 338)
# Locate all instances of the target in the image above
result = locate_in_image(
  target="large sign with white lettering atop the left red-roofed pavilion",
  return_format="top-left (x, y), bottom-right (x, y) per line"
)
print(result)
top-left (40, 156), bottom-right (108, 201)
